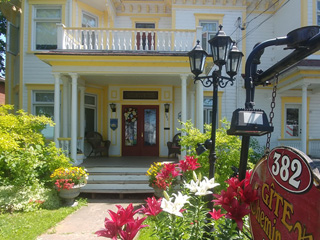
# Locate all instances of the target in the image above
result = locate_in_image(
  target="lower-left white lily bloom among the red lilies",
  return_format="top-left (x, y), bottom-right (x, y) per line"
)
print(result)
top-left (161, 192), bottom-right (189, 217)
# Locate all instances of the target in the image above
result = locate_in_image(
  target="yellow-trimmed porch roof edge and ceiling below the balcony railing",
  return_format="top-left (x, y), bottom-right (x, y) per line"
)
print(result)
top-left (35, 52), bottom-right (193, 86)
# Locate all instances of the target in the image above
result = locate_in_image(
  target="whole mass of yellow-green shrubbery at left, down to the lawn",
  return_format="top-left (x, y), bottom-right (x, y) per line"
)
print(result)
top-left (0, 105), bottom-right (71, 212)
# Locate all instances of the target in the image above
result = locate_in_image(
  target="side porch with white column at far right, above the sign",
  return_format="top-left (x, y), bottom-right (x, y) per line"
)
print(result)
top-left (277, 59), bottom-right (320, 158)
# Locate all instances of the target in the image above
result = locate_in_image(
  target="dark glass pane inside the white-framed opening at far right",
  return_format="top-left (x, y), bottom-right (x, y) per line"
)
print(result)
top-left (286, 107), bottom-right (300, 137)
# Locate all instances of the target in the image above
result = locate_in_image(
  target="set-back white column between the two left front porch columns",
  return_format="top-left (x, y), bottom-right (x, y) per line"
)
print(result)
top-left (62, 79), bottom-right (70, 138)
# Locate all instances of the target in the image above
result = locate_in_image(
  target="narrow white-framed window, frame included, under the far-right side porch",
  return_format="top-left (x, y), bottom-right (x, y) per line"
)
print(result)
top-left (285, 104), bottom-right (301, 138)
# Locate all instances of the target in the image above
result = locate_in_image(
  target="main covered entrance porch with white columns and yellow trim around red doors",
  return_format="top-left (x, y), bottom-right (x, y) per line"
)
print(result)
top-left (36, 51), bottom-right (210, 165)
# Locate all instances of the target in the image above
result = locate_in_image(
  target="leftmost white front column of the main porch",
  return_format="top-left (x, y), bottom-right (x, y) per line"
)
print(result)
top-left (53, 73), bottom-right (60, 147)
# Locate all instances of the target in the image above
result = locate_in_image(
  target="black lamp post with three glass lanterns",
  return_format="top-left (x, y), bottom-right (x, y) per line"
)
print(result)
top-left (188, 25), bottom-right (243, 189)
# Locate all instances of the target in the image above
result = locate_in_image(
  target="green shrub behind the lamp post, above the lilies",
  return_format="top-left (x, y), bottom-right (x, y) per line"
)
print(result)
top-left (179, 119), bottom-right (261, 191)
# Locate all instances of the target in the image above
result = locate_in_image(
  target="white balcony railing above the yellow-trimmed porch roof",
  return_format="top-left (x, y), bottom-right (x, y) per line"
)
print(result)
top-left (57, 24), bottom-right (198, 51)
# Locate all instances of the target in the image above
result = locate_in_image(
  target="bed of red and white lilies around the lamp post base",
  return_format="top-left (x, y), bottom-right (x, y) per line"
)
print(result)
top-left (96, 157), bottom-right (257, 240)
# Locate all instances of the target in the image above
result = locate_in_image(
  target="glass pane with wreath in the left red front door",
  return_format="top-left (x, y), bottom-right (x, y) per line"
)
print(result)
top-left (124, 108), bottom-right (138, 146)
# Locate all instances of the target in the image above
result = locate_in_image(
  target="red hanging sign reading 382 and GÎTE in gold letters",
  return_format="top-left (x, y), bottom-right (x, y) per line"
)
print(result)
top-left (250, 147), bottom-right (320, 240)
